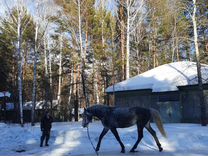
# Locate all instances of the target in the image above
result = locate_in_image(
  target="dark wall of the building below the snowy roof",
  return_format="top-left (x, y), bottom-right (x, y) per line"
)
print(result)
top-left (109, 87), bottom-right (208, 123)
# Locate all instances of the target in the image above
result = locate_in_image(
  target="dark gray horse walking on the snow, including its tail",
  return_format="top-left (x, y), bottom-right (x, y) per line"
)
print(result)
top-left (82, 105), bottom-right (166, 153)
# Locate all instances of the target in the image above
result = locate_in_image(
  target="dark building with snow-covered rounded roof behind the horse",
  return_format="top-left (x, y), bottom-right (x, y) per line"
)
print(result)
top-left (106, 61), bottom-right (208, 123)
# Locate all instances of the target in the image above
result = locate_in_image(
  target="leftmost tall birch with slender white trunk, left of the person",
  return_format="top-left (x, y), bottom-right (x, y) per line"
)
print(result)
top-left (2, 0), bottom-right (31, 126)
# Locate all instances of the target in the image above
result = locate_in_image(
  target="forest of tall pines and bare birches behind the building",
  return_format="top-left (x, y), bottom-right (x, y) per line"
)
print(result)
top-left (0, 0), bottom-right (208, 123)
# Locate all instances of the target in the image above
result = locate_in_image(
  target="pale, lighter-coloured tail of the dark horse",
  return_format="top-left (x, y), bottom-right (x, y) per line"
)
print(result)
top-left (150, 108), bottom-right (167, 137)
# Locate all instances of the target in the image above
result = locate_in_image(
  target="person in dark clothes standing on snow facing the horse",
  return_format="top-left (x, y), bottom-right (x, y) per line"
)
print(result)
top-left (40, 111), bottom-right (53, 147)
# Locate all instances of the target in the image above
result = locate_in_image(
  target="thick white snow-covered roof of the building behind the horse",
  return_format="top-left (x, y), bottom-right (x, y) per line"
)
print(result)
top-left (106, 61), bottom-right (208, 92)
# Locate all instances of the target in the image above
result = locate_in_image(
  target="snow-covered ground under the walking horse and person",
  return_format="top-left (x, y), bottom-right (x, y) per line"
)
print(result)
top-left (0, 122), bottom-right (208, 156)
